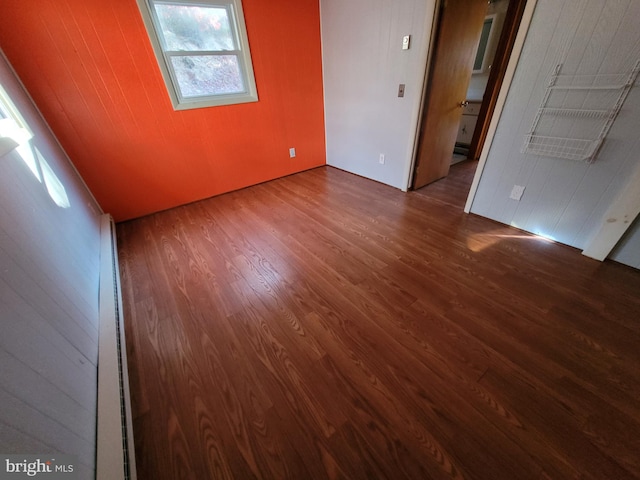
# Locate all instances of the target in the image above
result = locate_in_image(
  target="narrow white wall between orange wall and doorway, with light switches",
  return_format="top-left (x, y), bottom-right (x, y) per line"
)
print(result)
top-left (320, 0), bottom-right (435, 188)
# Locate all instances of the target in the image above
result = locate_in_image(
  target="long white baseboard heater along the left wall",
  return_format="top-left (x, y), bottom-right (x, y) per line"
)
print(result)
top-left (96, 215), bottom-right (137, 480)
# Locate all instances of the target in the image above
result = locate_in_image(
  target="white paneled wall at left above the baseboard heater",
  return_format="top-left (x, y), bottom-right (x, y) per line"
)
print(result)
top-left (0, 51), bottom-right (100, 479)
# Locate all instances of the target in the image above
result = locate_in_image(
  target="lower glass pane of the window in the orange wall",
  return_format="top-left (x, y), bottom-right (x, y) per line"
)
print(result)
top-left (171, 55), bottom-right (245, 98)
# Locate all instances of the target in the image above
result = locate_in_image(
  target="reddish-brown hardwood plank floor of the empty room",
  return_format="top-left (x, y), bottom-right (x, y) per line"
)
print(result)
top-left (118, 162), bottom-right (640, 480)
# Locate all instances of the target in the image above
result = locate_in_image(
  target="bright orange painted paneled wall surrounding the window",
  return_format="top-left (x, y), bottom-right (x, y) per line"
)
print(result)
top-left (0, 0), bottom-right (325, 221)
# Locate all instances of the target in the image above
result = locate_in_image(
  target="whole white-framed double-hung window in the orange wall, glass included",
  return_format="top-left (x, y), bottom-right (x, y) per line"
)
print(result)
top-left (138, 0), bottom-right (258, 110)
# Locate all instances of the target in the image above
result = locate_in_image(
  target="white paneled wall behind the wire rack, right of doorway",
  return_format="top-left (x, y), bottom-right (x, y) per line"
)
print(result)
top-left (471, 0), bottom-right (640, 266)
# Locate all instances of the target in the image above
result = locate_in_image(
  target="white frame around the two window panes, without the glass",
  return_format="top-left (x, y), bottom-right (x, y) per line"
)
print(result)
top-left (137, 0), bottom-right (258, 110)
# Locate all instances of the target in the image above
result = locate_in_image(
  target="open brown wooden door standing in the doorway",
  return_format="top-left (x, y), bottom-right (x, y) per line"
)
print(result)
top-left (413, 0), bottom-right (488, 188)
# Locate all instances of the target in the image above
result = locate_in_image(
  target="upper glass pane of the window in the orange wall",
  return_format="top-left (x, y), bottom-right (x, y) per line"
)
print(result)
top-left (154, 3), bottom-right (236, 51)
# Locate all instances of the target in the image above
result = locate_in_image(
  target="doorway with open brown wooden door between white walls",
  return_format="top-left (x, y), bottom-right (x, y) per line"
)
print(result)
top-left (410, 0), bottom-right (527, 194)
